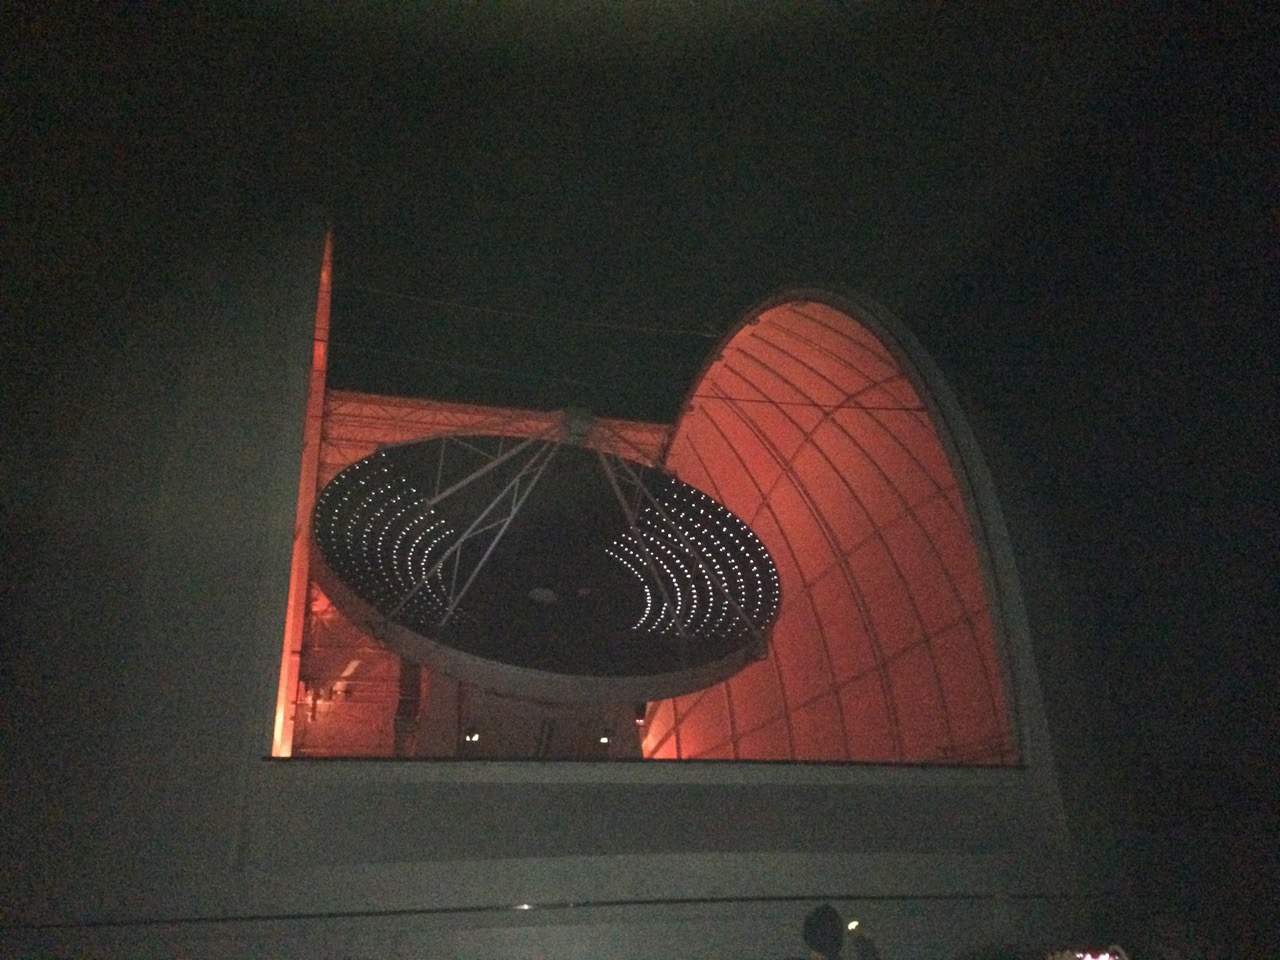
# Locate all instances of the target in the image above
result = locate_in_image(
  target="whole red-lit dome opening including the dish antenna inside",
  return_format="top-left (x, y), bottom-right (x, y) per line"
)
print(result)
top-left (273, 239), bottom-right (1019, 765)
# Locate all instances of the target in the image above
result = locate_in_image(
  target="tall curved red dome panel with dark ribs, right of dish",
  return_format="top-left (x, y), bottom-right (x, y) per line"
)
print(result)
top-left (644, 301), bottom-right (1016, 763)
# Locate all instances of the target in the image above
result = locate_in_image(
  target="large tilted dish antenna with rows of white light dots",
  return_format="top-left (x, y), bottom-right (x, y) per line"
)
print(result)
top-left (312, 436), bottom-right (781, 703)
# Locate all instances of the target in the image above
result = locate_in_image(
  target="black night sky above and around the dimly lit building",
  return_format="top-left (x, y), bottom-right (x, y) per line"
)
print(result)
top-left (0, 0), bottom-right (1280, 957)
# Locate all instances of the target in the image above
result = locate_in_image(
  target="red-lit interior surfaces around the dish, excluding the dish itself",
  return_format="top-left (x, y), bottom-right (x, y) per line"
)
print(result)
top-left (273, 251), bottom-right (1018, 764)
